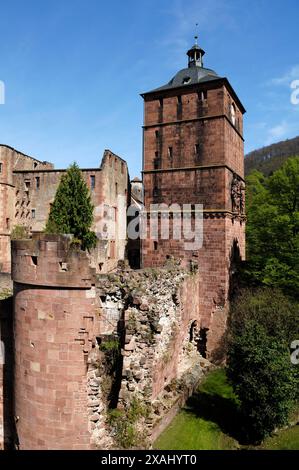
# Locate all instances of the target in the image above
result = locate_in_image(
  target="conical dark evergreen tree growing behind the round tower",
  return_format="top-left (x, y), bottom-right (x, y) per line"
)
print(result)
top-left (45, 163), bottom-right (97, 250)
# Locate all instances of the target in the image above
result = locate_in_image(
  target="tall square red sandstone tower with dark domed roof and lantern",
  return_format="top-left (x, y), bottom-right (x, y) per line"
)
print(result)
top-left (142, 37), bottom-right (245, 353)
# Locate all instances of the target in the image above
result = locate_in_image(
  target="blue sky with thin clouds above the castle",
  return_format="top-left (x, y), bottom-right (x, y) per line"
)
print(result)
top-left (0, 0), bottom-right (299, 177)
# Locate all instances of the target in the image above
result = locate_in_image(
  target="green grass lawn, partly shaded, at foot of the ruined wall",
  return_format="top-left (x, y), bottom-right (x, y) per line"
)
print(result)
top-left (154, 369), bottom-right (299, 450)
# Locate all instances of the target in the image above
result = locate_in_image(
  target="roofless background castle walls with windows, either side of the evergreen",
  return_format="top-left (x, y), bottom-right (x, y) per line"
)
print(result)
top-left (0, 146), bottom-right (129, 272)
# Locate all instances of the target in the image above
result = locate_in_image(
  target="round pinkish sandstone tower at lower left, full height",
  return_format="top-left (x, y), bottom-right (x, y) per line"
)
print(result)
top-left (12, 234), bottom-right (98, 450)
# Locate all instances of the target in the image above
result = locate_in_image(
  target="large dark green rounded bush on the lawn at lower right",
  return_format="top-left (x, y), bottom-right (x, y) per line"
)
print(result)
top-left (227, 288), bottom-right (299, 442)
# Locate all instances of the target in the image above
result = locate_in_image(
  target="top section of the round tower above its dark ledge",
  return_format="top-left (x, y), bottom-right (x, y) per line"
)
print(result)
top-left (12, 233), bottom-right (95, 289)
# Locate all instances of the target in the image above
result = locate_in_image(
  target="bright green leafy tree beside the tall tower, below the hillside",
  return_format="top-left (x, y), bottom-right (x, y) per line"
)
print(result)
top-left (246, 157), bottom-right (299, 297)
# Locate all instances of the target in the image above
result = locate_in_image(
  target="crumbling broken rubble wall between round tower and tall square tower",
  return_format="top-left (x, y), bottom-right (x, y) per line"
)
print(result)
top-left (97, 260), bottom-right (210, 447)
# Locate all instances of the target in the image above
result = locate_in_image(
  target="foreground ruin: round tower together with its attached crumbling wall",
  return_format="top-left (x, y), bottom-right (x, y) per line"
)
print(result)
top-left (2, 234), bottom-right (209, 449)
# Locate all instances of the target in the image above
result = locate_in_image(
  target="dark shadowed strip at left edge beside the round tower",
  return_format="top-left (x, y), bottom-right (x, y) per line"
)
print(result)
top-left (0, 297), bottom-right (17, 450)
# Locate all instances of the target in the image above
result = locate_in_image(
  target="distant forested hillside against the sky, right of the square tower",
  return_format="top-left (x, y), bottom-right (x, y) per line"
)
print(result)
top-left (245, 136), bottom-right (299, 176)
